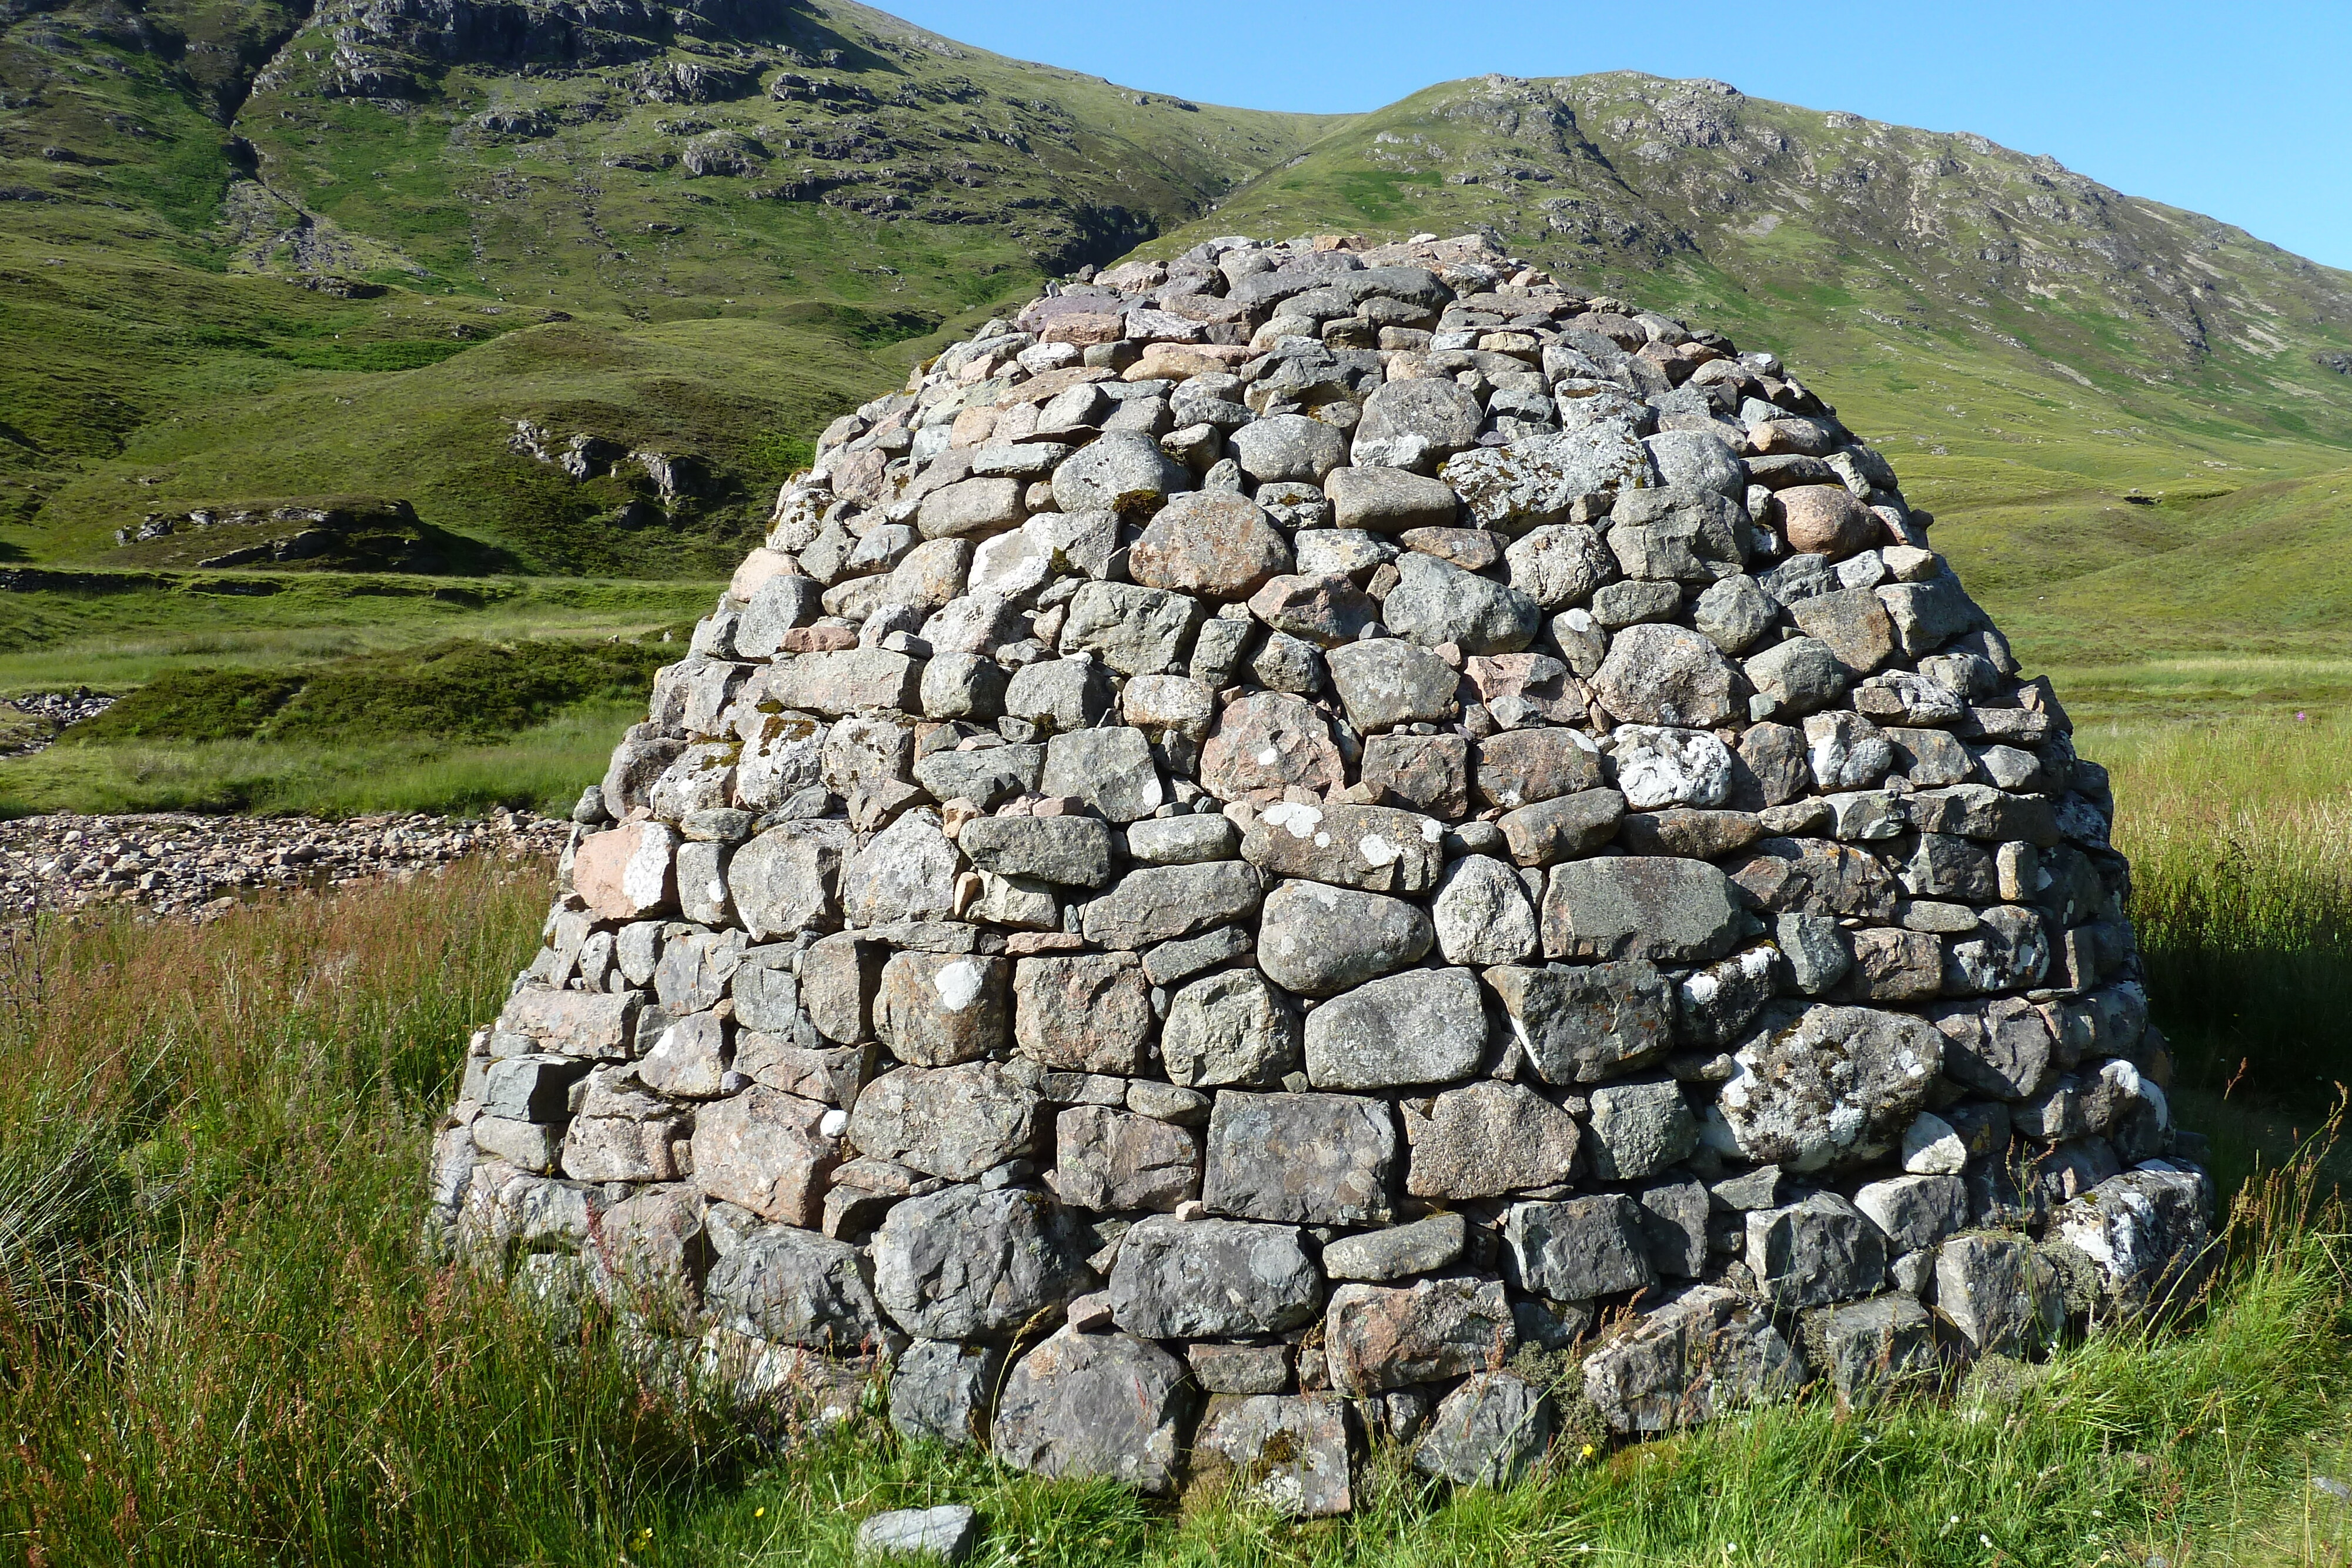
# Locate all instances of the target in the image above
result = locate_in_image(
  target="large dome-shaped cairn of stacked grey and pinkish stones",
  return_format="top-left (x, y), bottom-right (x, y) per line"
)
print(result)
top-left (435, 235), bottom-right (2213, 1514)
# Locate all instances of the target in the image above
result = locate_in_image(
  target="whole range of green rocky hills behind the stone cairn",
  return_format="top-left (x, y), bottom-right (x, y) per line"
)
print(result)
top-left (0, 0), bottom-right (2352, 594)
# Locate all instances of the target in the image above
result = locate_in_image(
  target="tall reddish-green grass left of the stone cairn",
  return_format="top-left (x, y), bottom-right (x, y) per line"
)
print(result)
top-left (0, 865), bottom-right (753, 1566)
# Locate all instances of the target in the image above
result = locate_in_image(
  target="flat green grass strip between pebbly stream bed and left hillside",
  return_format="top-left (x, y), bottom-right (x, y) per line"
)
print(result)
top-left (0, 574), bottom-right (720, 815)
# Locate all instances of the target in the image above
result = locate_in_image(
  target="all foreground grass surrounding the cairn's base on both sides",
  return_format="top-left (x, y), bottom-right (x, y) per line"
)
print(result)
top-left (0, 720), bottom-right (2352, 1568)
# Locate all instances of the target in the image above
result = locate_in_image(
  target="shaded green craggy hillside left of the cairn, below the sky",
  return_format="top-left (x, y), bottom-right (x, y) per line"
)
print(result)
top-left (0, 0), bottom-right (1327, 576)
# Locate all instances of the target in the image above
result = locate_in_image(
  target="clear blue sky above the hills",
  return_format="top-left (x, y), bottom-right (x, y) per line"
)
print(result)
top-left (882, 0), bottom-right (2352, 268)
